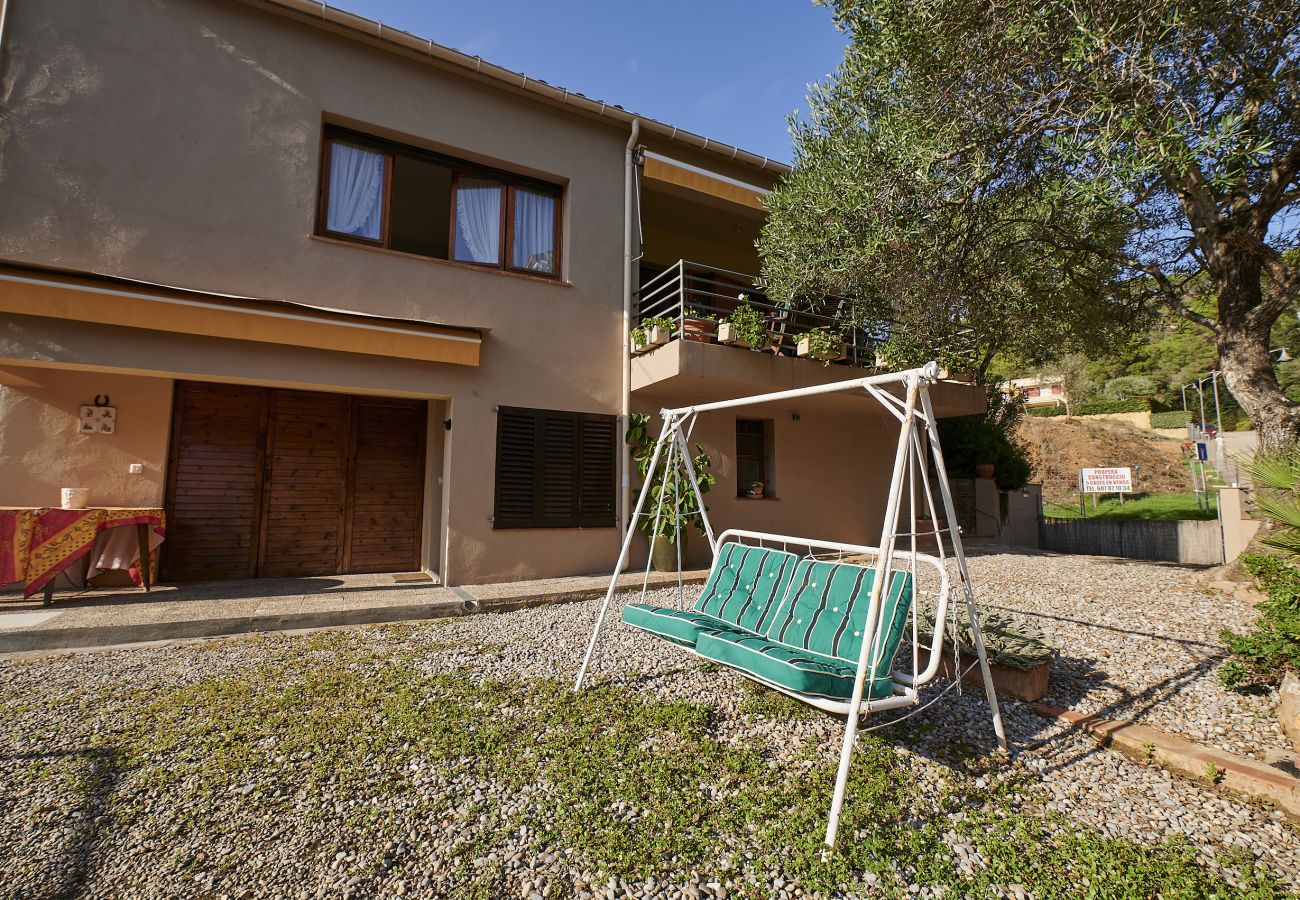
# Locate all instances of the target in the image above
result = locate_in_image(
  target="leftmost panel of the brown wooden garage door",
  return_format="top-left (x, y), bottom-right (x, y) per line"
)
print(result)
top-left (163, 382), bottom-right (267, 580)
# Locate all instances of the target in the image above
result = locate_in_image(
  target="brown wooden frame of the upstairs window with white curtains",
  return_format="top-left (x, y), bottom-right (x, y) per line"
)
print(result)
top-left (316, 125), bottom-right (566, 281)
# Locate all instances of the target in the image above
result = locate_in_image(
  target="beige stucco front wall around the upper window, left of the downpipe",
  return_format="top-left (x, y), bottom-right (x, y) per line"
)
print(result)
top-left (0, 0), bottom-right (627, 583)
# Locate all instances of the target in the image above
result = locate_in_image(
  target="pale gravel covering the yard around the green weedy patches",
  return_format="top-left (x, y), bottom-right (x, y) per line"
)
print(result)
top-left (0, 555), bottom-right (1300, 900)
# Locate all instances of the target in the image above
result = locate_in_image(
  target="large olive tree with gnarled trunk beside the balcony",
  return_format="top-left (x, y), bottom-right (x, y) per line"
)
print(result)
top-left (759, 0), bottom-right (1300, 446)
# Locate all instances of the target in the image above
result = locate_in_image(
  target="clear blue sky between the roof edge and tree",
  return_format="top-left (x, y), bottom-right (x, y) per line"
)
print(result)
top-left (332, 0), bottom-right (845, 161)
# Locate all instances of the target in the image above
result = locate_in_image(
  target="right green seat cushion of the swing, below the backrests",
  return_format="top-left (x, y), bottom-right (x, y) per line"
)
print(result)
top-left (696, 633), bottom-right (893, 700)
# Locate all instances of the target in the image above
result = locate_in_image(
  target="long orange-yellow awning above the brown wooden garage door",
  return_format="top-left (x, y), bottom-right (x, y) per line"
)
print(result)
top-left (0, 263), bottom-right (486, 365)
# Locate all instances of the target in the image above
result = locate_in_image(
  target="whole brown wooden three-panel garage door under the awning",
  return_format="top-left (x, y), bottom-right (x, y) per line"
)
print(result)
top-left (163, 382), bottom-right (428, 580)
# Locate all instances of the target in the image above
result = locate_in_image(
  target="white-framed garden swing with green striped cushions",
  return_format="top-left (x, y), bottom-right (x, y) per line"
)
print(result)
top-left (575, 362), bottom-right (1006, 847)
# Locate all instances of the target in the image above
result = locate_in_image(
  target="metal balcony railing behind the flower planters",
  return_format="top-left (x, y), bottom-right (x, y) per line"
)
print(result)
top-left (636, 260), bottom-right (892, 367)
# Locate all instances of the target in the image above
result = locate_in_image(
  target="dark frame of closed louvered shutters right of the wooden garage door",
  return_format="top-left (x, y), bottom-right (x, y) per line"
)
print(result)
top-left (491, 406), bottom-right (619, 531)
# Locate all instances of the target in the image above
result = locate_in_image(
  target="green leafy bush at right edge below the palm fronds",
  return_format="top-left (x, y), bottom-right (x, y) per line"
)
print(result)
top-left (1218, 555), bottom-right (1300, 691)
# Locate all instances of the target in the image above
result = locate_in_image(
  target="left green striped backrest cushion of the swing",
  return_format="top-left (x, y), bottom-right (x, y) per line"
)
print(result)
top-left (696, 541), bottom-right (800, 635)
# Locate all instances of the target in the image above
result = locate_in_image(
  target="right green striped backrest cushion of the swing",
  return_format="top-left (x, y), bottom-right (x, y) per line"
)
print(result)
top-left (761, 559), bottom-right (913, 676)
